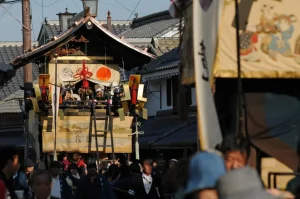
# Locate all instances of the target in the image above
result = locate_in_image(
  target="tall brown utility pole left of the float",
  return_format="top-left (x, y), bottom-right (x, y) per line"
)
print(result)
top-left (22, 0), bottom-right (33, 159)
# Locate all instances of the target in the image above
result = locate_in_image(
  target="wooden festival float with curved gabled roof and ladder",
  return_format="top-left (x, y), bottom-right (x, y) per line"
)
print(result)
top-left (12, 9), bottom-right (155, 162)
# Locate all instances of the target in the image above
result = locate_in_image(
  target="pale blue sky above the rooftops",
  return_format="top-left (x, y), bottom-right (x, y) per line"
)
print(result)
top-left (0, 0), bottom-right (170, 41)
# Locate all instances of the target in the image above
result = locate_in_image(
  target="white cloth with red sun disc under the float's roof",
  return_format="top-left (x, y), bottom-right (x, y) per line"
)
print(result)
top-left (49, 63), bottom-right (120, 86)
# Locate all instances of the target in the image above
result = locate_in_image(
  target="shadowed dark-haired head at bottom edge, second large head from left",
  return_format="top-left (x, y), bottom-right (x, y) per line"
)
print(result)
top-left (29, 170), bottom-right (52, 199)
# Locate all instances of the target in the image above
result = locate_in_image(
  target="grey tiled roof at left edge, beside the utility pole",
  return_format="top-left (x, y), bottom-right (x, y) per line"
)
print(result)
top-left (0, 42), bottom-right (38, 113)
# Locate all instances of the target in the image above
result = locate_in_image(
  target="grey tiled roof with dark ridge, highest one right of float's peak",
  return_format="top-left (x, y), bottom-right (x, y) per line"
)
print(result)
top-left (121, 11), bottom-right (179, 38)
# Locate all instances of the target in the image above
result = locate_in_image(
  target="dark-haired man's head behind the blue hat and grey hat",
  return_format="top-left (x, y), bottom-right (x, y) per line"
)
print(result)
top-left (219, 136), bottom-right (250, 171)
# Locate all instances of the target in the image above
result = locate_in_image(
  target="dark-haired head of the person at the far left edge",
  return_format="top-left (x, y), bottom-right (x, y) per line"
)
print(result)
top-left (0, 146), bottom-right (19, 176)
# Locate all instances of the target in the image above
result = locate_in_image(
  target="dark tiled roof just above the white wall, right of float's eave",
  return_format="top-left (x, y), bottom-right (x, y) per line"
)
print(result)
top-left (141, 47), bottom-right (179, 74)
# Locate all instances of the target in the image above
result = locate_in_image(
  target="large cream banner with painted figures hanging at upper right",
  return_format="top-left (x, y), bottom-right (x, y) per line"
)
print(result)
top-left (214, 0), bottom-right (300, 78)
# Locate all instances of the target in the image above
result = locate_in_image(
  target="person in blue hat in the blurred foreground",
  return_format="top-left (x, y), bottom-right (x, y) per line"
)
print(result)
top-left (183, 152), bottom-right (226, 199)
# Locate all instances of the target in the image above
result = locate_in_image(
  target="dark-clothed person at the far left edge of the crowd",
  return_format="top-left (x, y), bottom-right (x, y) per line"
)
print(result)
top-left (0, 146), bottom-right (19, 199)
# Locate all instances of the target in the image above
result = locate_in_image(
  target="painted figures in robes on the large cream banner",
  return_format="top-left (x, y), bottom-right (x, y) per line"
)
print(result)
top-left (240, 4), bottom-right (297, 62)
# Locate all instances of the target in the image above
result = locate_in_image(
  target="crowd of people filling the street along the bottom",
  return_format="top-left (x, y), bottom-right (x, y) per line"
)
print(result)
top-left (0, 138), bottom-right (300, 199)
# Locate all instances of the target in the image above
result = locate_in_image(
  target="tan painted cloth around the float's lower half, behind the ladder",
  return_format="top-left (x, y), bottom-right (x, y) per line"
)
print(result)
top-left (41, 114), bottom-right (132, 153)
